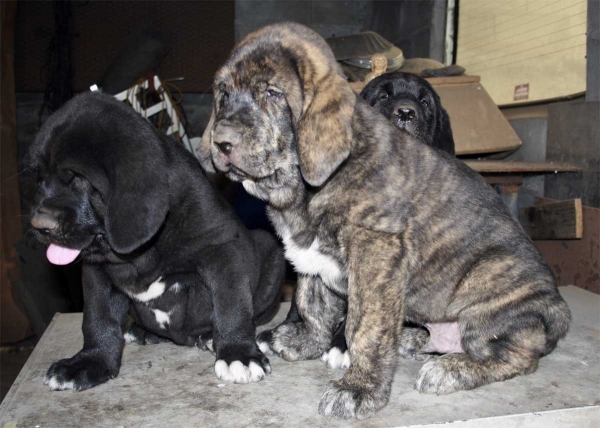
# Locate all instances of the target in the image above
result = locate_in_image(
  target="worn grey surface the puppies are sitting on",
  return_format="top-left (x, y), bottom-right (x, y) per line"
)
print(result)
top-left (0, 287), bottom-right (600, 428)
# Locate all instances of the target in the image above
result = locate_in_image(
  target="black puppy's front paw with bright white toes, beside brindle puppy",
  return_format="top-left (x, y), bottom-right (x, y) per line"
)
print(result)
top-left (215, 342), bottom-right (271, 383)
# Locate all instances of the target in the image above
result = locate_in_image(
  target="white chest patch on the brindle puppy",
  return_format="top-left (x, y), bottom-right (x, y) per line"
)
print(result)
top-left (281, 230), bottom-right (343, 286)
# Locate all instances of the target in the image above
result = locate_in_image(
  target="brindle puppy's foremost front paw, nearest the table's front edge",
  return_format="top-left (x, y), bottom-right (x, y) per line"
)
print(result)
top-left (319, 380), bottom-right (389, 419)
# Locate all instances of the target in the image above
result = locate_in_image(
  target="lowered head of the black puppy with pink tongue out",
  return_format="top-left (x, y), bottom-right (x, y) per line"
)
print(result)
top-left (28, 93), bottom-right (168, 264)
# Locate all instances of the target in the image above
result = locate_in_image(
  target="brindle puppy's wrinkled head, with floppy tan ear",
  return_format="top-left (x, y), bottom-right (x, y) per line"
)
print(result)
top-left (199, 23), bottom-right (356, 206)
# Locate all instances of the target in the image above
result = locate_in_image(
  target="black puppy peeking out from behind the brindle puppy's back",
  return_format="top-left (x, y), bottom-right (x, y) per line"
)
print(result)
top-left (360, 72), bottom-right (455, 155)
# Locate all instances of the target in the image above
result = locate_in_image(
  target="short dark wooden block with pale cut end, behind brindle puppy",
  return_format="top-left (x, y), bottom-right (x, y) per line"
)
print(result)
top-left (519, 199), bottom-right (583, 239)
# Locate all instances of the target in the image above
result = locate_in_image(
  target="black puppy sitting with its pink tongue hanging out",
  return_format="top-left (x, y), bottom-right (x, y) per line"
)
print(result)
top-left (30, 93), bottom-right (285, 391)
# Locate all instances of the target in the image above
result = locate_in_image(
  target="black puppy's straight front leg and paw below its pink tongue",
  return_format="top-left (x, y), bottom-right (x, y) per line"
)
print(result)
top-left (44, 265), bottom-right (130, 391)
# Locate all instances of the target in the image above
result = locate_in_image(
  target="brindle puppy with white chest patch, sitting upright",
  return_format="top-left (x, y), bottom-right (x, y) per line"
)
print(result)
top-left (200, 23), bottom-right (570, 418)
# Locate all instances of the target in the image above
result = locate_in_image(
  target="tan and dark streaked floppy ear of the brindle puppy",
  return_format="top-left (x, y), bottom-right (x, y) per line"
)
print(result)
top-left (297, 64), bottom-right (356, 186)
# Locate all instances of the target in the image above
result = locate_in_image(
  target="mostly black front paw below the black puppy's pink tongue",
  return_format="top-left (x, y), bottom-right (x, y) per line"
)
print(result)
top-left (44, 353), bottom-right (119, 391)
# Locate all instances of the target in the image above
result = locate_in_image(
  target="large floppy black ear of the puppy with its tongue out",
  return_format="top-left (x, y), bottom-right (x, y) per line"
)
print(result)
top-left (104, 124), bottom-right (169, 254)
